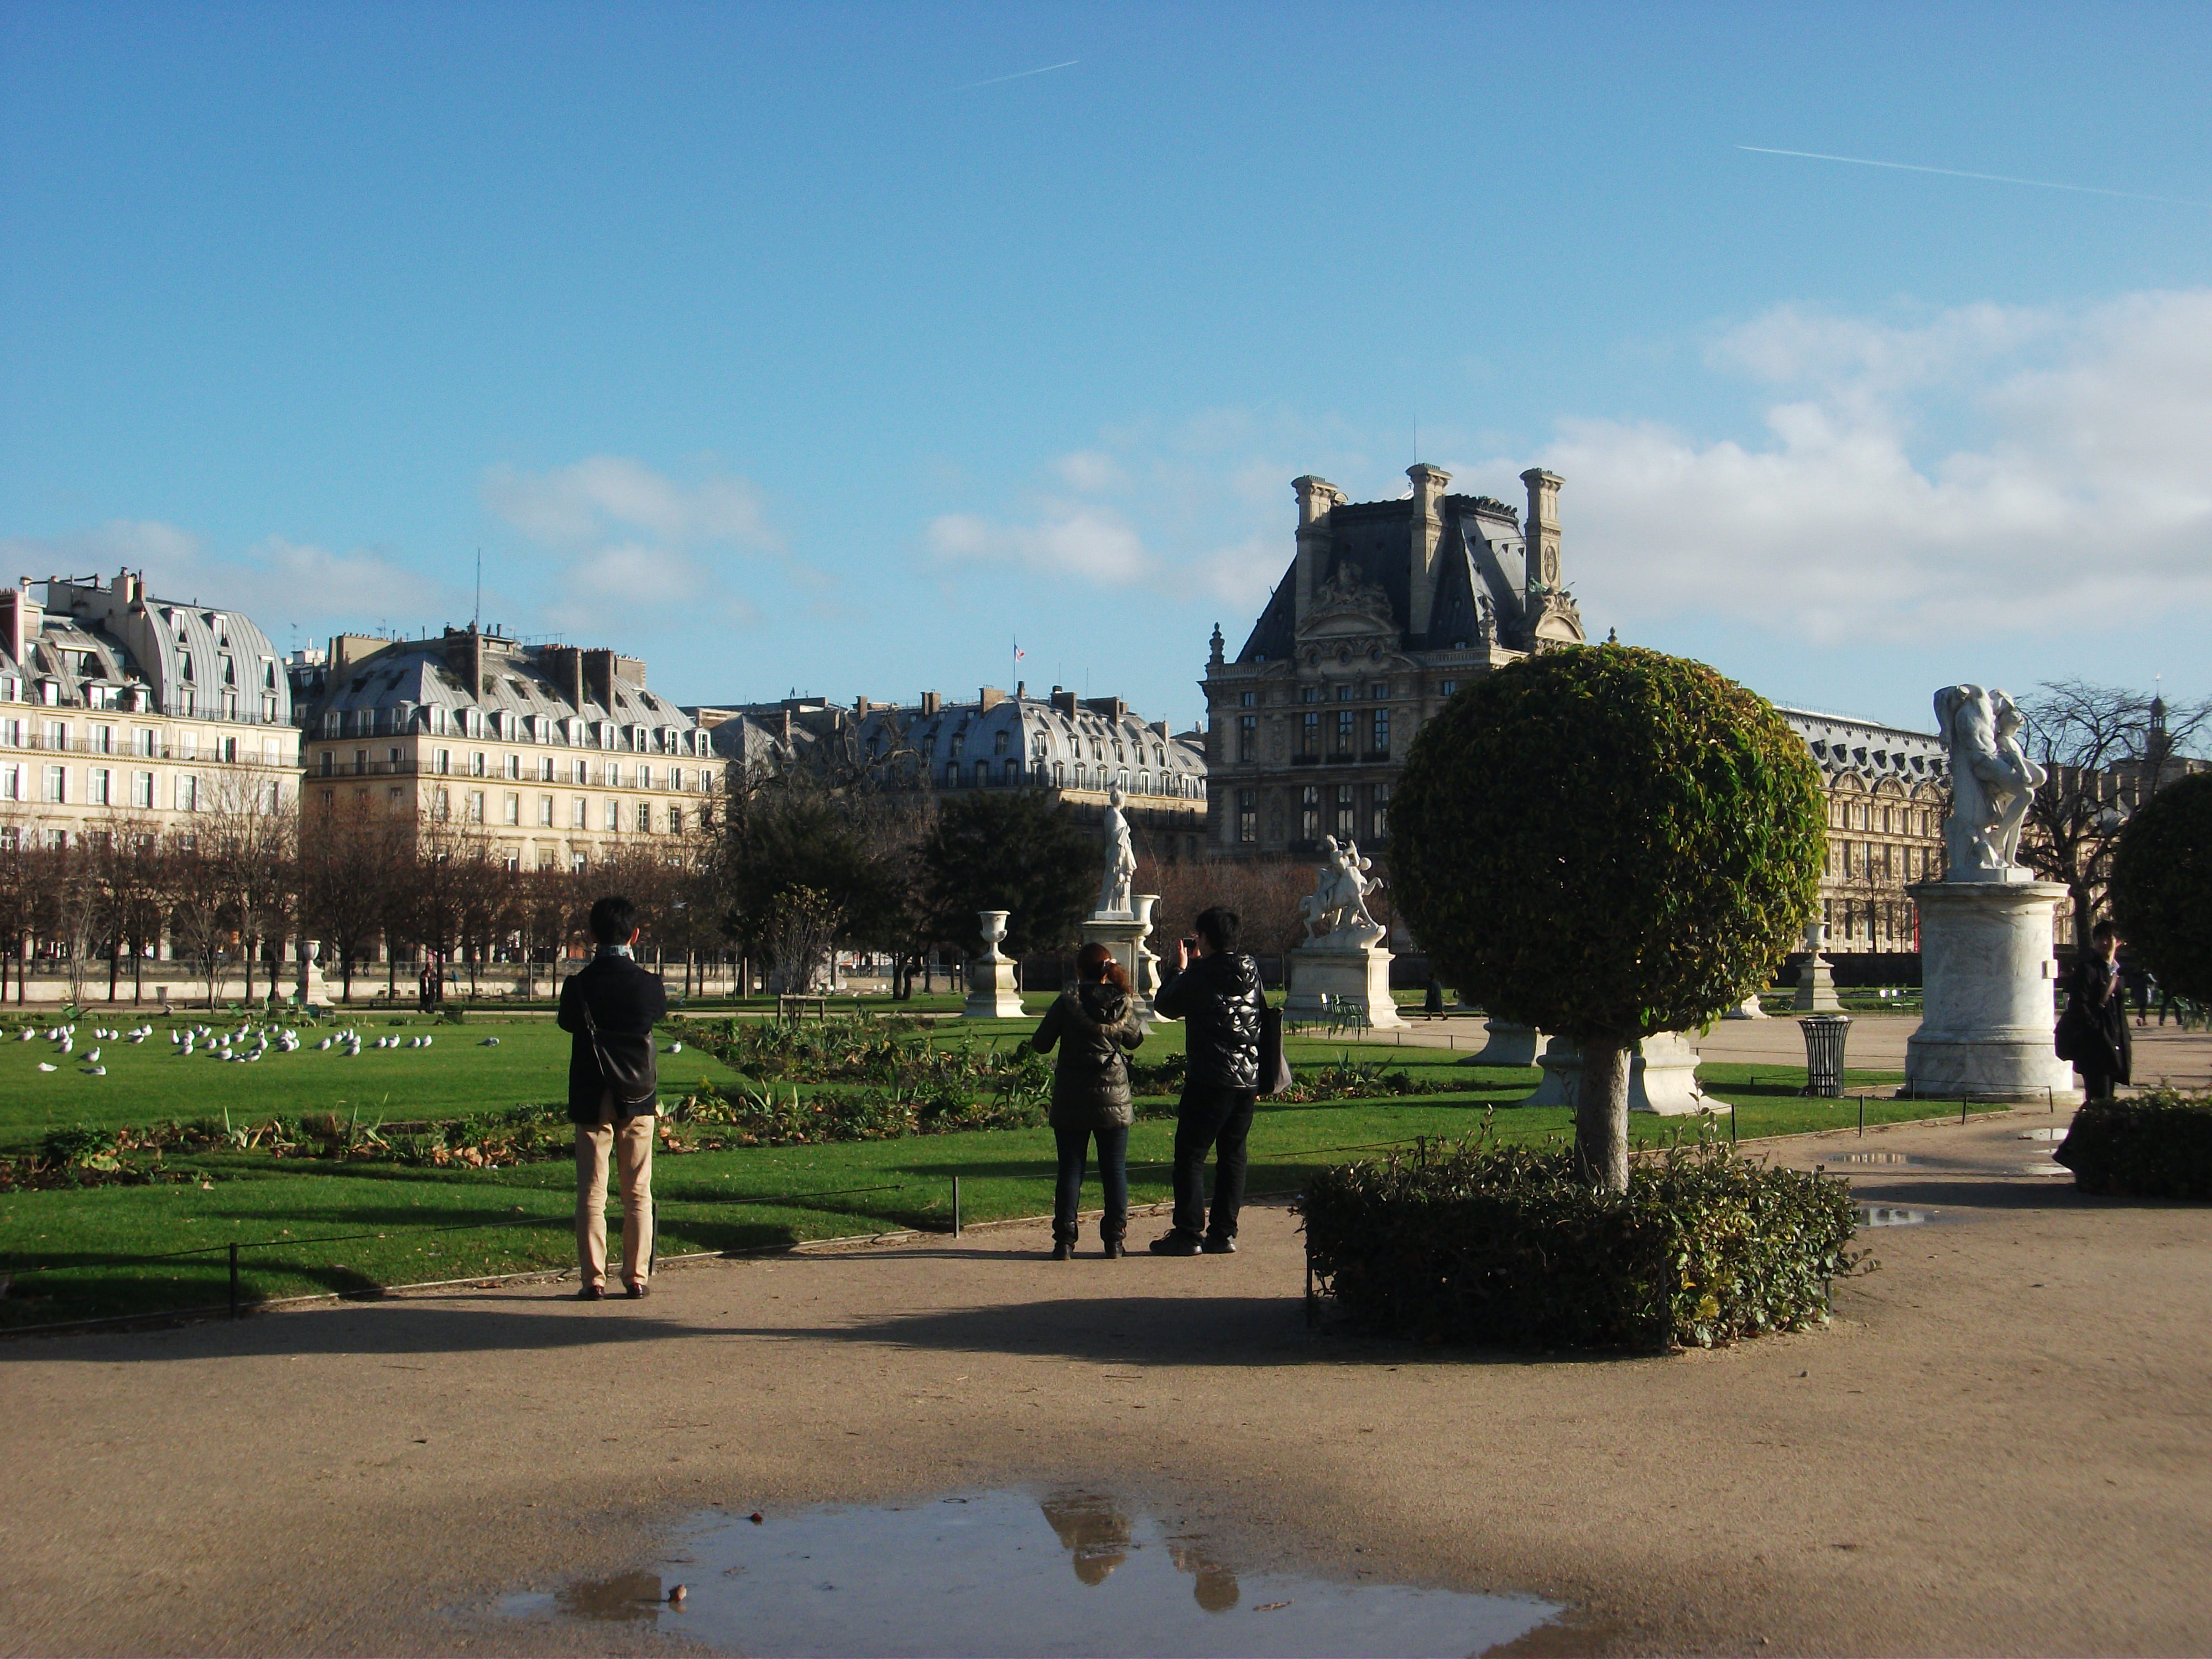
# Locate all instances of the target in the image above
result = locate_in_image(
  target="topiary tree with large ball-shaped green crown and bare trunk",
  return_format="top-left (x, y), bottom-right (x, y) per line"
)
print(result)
top-left (1389, 646), bottom-right (1827, 1192)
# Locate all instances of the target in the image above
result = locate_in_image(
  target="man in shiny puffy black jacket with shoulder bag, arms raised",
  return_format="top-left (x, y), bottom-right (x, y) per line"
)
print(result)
top-left (1152, 905), bottom-right (1267, 1256)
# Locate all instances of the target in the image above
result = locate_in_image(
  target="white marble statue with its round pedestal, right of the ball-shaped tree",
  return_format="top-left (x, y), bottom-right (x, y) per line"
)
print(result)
top-left (1902, 686), bottom-right (2081, 1104)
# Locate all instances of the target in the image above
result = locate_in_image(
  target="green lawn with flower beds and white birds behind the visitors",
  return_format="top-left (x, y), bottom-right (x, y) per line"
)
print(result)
top-left (0, 1020), bottom-right (2000, 1327)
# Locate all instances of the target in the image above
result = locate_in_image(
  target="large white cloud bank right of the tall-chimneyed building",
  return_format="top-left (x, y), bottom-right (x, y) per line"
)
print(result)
top-left (1540, 292), bottom-right (2212, 644)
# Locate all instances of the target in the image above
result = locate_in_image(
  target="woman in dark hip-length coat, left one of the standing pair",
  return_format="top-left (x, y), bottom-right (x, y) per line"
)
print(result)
top-left (1029, 945), bottom-right (1144, 1261)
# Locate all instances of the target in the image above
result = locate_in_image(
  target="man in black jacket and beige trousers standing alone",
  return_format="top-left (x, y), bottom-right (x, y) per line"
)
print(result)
top-left (560, 896), bottom-right (668, 1303)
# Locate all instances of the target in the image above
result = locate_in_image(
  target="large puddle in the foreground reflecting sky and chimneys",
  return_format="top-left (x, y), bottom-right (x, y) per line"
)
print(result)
top-left (498, 1489), bottom-right (1562, 1659)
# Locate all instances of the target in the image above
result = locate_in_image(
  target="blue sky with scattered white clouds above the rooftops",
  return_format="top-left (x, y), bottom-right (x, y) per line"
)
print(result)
top-left (0, 4), bottom-right (2212, 726)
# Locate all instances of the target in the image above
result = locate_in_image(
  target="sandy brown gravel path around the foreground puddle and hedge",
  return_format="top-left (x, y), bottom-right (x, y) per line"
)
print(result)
top-left (0, 1113), bottom-right (2212, 1652)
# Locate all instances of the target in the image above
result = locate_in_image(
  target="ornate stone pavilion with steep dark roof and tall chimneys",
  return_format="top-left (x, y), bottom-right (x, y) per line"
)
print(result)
top-left (1206, 465), bottom-right (1584, 858)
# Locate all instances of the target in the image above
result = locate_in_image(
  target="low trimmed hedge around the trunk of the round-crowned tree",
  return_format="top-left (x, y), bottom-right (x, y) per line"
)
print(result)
top-left (1298, 1141), bottom-right (1863, 1349)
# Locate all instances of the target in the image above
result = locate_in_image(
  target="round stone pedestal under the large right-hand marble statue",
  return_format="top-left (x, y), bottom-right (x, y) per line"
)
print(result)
top-left (1900, 880), bottom-right (2081, 1104)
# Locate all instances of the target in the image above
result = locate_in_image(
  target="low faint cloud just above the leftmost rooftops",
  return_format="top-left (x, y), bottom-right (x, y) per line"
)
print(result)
top-left (0, 520), bottom-right (453, 644)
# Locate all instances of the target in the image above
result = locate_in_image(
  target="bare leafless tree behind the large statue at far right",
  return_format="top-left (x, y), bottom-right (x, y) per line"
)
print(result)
top-left (2020, 679), bottom-right (2212, 942)
